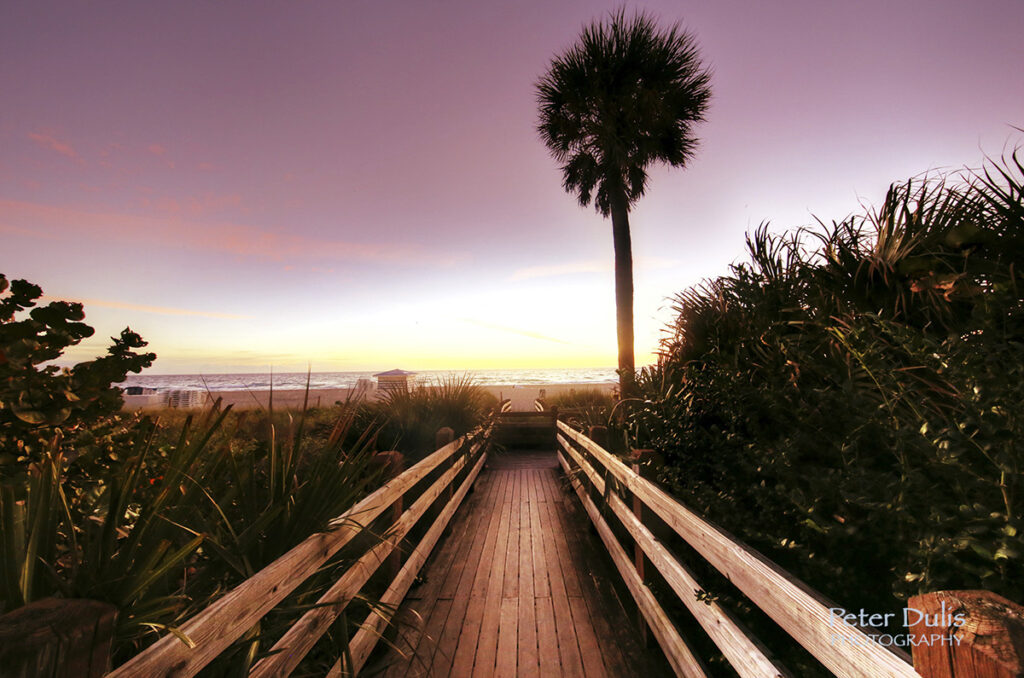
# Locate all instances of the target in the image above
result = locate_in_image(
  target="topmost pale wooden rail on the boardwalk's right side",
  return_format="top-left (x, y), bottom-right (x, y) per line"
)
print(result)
top-left (558, 422), bottom-right (920, 678)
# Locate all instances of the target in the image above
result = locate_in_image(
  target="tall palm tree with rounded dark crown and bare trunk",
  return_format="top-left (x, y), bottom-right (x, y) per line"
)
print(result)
top-left (537, 9), bottom-right (711, 396)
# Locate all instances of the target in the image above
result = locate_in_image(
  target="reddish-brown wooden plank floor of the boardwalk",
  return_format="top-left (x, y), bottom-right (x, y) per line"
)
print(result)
top-left (362, 452), bottom-right (669, 678)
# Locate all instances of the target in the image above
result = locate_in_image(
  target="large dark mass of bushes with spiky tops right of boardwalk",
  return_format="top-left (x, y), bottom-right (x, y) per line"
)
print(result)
top-left (630, 154), bottom-right (1024, 667)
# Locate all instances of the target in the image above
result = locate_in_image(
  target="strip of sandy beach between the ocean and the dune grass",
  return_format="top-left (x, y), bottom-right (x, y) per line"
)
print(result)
top-left (119, 382), bottom-right (618, 412)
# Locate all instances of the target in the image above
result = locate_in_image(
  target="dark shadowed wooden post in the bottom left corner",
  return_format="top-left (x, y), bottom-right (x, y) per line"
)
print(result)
top-left (0, 598), bottom-right (118, 678)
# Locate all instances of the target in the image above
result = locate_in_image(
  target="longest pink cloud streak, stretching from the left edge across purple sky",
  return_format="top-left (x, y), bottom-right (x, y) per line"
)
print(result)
top-left (0, 197), bottom-right (458, 266)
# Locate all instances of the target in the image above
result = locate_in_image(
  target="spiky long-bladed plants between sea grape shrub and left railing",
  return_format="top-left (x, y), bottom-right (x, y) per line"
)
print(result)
top-left (0, 395), bottom-right (379, 670)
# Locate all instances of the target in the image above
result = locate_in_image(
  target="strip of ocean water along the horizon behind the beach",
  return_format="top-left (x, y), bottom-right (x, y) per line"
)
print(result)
top-left (120, 368), bottom-right (618, 391)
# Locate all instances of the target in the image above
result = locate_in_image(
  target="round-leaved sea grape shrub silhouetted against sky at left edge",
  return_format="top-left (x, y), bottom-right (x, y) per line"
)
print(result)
top-left (0, 273), bottom-right (157, 465)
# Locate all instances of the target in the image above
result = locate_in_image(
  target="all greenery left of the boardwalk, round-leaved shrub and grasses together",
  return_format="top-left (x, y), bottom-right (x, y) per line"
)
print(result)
top-left (0, 277), bottom-right (487, 674)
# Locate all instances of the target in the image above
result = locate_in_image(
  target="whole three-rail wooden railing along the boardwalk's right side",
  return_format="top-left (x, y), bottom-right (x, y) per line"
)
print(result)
top-left (557, 422), bottom-right (929, 678)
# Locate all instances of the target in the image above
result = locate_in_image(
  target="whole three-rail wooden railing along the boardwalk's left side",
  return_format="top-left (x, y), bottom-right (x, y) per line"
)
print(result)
top-left (103, 429), bottom-right (487, 678)
